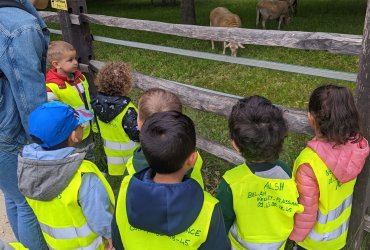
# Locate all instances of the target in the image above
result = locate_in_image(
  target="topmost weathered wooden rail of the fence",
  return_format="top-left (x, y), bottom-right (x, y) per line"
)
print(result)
top-left (40, 11), bottom-right (362, 55)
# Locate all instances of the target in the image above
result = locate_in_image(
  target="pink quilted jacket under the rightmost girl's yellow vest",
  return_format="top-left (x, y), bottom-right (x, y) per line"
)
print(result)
top-left (289, 137), bottom-right (370, 242)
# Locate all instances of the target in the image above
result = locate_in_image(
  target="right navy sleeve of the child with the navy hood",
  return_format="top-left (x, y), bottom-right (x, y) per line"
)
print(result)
top-left (199, 203), bottom-right (231, 250)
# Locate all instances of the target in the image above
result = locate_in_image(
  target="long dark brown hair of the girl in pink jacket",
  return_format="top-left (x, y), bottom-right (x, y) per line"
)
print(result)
top-left (308, 85), bottom-right (361, 144)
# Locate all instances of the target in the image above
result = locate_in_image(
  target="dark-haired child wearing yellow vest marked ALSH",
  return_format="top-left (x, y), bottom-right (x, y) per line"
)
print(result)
top-left (217, 96), bottom-right (302, 250)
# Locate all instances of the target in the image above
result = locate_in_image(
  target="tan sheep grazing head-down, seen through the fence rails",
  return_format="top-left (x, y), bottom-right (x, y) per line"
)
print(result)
top-left (209, 7), bottom-right (244, 56)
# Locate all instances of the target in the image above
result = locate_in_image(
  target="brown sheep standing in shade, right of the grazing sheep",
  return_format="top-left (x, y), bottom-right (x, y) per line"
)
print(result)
top-left (256, 0), bottom-right (290, 29)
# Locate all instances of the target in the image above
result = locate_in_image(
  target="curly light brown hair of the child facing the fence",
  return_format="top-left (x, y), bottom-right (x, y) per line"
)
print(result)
top-left (96, 62), bottom-right (133, 96)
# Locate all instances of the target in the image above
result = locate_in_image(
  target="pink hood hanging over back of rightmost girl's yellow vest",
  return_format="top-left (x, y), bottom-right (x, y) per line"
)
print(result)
top-left (307, 137), bottom-right (370, 183)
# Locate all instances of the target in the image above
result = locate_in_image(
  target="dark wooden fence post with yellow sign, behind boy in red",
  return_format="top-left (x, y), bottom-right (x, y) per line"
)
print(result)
top-left (58, 0), bottom-right (96, 95)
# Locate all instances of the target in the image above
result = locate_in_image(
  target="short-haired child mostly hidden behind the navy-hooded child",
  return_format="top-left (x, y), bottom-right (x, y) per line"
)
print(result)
top-left (124, 88), bottom-right (204, 188)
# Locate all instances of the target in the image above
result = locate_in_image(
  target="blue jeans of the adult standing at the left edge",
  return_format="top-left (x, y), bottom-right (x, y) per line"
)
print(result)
top-left (0, 151), bottom-right (48, 250)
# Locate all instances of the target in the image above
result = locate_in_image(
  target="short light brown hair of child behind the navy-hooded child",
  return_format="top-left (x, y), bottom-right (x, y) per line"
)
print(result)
top-left (138, 88), bottom-right (182, 122)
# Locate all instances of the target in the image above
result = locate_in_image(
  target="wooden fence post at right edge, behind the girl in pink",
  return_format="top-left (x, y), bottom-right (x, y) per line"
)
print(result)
top-left (347, 0), bottom-right (370, 250)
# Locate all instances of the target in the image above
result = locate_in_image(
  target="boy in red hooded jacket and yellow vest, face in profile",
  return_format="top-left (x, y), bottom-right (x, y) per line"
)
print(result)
top-left (46, 41), bottom-right (97, 161)
